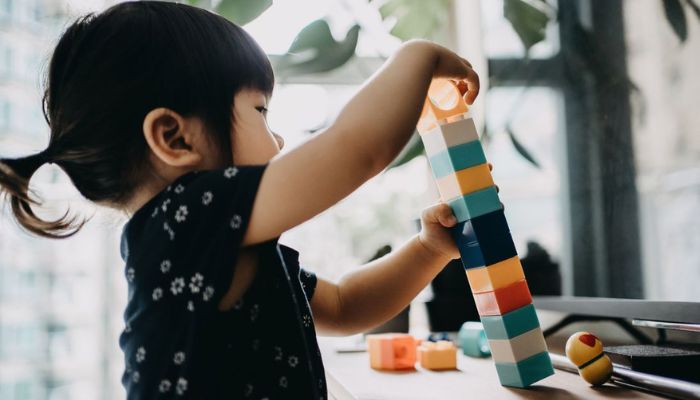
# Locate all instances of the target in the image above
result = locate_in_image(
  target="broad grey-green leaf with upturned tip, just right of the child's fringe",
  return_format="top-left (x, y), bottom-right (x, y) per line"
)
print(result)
top-left (274, 19), bottom-right (360, 76)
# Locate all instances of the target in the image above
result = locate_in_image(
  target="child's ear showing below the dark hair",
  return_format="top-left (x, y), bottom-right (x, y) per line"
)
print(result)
top-left (143, 107), bottom-right (202, 167)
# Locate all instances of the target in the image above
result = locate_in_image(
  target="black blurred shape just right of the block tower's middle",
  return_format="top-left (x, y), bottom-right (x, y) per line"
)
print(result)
top-left (520, 241), bottom-right (561, 296)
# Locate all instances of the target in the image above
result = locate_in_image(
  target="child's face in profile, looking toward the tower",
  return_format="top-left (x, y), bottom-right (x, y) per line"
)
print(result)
top-left (231, 89), bottom-right (284, 165)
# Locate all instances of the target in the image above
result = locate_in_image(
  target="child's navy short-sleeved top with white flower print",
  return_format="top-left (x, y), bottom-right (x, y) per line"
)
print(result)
top-left (119, 164), bottom-right (327, 400)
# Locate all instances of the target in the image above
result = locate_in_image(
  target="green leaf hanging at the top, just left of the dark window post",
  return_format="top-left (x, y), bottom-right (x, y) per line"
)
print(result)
top-left (503, 0), bottom-right (549, 52)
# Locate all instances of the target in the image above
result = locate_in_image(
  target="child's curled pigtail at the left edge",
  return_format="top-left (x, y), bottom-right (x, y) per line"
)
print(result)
top-left (0, 151), bottom-right (85, 239)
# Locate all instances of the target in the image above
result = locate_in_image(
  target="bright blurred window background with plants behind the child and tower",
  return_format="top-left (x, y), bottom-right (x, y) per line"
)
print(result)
top-left (0, 0), bottom-right (700, 400)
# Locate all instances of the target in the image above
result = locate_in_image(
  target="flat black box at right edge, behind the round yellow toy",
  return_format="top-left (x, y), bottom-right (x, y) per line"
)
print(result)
top-left (605, 343), bottom-right (700, 383)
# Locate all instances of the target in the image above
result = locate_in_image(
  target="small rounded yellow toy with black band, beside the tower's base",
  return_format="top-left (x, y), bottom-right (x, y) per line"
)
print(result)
top-left (566, 332), bottom-right (613, 386)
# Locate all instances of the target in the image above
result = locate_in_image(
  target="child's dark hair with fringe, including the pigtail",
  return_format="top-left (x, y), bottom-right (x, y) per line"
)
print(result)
top-left (0, 1), bottom-right (274, 238)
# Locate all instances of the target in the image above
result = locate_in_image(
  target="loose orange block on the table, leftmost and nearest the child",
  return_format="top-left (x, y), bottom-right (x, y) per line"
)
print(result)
top-left (367, 333), bottom-right (416, 370)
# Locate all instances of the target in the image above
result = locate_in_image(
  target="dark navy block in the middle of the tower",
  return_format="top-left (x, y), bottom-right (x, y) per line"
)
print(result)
top-left (451, 209), bottom-right (518, 269)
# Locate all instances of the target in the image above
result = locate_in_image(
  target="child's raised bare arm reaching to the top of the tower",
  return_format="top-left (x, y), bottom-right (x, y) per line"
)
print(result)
top-left (243, 40), bottom-right (479, 245)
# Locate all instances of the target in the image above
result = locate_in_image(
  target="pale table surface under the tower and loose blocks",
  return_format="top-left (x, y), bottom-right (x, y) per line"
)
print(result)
top-left (319, 337), bottom-right (660, 400)
